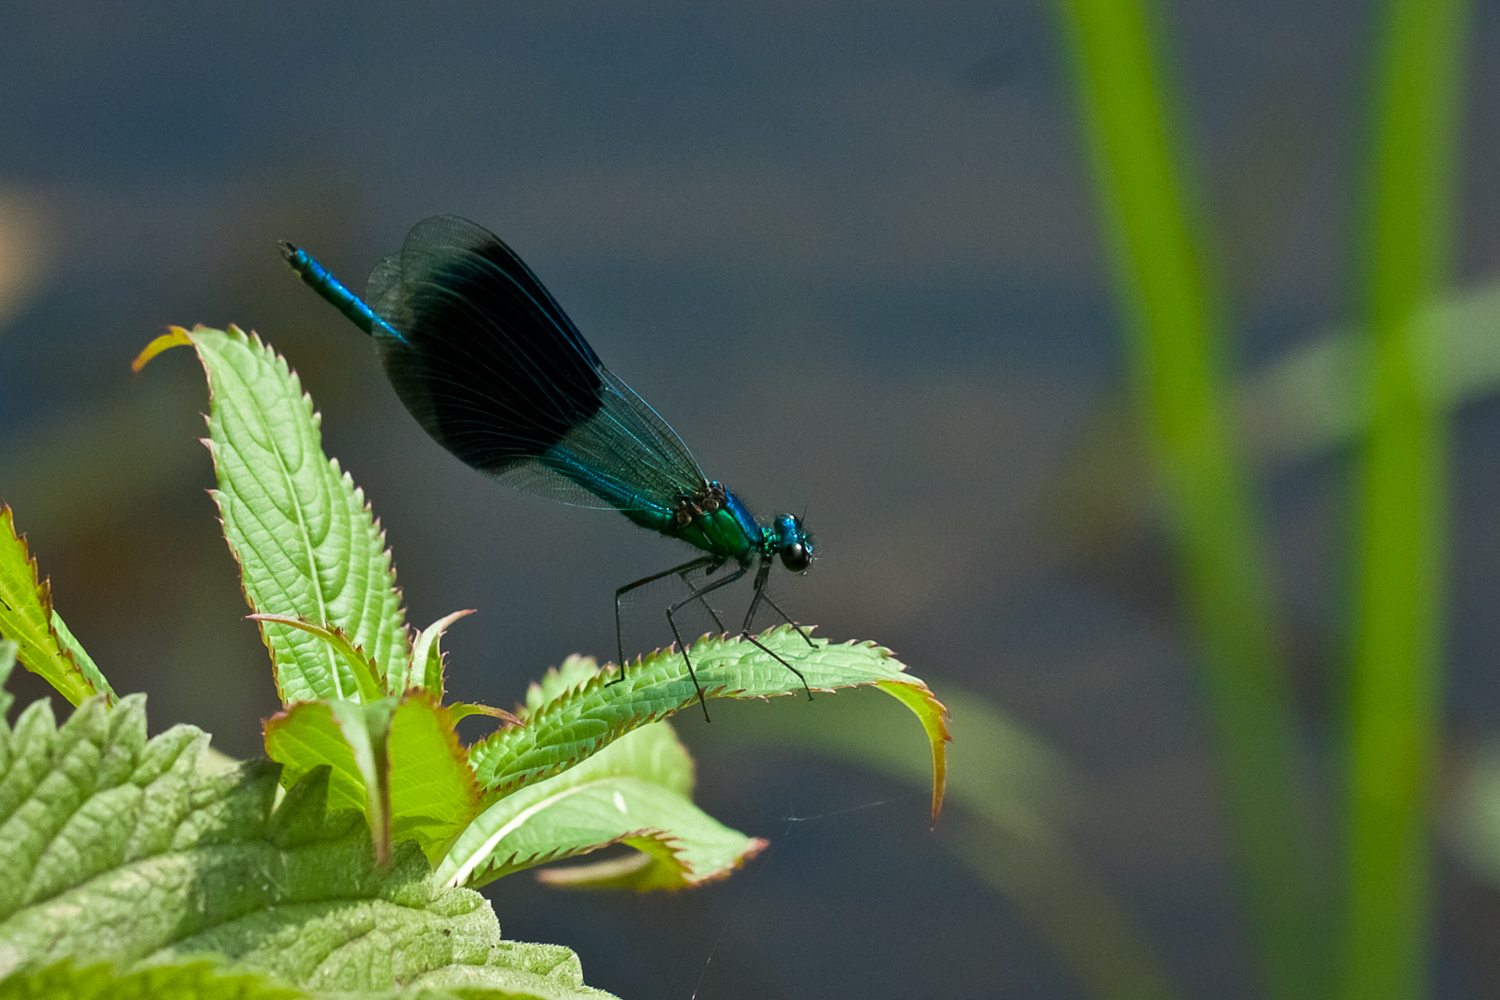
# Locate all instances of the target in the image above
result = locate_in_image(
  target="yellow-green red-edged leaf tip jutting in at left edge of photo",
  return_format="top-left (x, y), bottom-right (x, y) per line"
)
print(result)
top-left (0, 504), bottom-right (116, 705)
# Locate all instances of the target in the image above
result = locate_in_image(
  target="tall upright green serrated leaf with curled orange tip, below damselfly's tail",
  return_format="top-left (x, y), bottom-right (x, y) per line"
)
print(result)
top-left (137, 327), bottom-right (410, 705)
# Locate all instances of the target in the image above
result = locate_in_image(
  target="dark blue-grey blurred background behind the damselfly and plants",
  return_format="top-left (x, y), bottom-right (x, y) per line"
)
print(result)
top-left (0, 0), bottom-right (1500, 1000)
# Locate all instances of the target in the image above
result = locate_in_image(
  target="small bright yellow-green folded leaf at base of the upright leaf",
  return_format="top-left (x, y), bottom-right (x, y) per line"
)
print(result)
top-left (266, 691), bottom-right (480, 864)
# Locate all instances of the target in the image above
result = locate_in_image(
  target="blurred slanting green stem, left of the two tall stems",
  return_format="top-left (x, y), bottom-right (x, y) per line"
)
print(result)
top-left (1059, 0), bottom-right (1325, 1000)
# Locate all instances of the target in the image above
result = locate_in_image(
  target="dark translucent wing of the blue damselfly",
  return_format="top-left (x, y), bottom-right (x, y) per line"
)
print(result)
top-left (368, 216), bottom-right (704, 510)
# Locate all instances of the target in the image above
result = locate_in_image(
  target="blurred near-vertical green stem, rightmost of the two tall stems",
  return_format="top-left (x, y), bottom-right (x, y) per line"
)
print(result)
top-left (1341, 0), bottom-right (1466, 1000)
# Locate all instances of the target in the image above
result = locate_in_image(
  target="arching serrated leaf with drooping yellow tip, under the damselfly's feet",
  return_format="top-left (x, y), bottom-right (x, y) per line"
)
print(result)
top-left (470, 625), bottom-right (950, 823)
